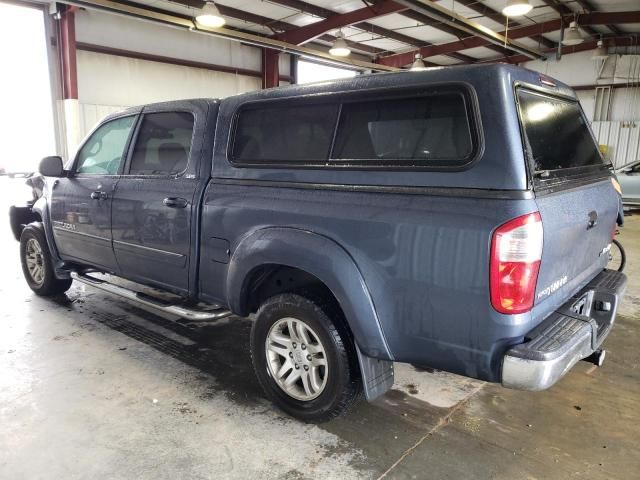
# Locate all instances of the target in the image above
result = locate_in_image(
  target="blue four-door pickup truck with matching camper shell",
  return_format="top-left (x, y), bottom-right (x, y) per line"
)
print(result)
top-left (11, 65), bottom-right (626, 422)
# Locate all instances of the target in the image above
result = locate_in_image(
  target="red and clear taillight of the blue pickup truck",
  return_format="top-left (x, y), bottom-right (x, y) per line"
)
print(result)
top-left (489, 212), bottom-right (542, 314)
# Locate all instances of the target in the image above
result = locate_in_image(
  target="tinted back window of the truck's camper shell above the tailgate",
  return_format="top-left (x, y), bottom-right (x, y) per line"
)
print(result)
top-left (518, 90), bottom-right (605, 180)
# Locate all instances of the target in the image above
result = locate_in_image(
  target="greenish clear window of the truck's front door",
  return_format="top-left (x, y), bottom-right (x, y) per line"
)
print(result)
top-left (76, 115), bottom-right (136, 175)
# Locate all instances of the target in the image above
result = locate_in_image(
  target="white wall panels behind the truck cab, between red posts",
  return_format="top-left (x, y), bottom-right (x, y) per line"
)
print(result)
top-left (67, 10), bottom-right (276, 144)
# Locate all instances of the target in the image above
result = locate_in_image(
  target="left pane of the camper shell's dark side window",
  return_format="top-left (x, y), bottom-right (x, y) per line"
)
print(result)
top-left (233, 104), bottom-right (338, 164)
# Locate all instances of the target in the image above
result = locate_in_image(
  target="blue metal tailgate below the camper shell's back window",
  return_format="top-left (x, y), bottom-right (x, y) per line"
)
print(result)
top-left (535, 178), bottom-right (619, 304)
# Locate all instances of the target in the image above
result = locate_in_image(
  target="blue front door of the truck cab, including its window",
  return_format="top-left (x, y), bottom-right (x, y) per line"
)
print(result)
top-left (51, 115), bottom-right (137, 272)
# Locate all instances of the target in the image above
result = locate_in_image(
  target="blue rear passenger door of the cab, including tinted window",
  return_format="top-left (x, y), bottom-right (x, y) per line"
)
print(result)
top-left (112, 111), bottom-right (198, 293)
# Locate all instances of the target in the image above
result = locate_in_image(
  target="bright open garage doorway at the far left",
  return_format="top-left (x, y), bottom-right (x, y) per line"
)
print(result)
top-left (0, 3), bottom-right (56, 174)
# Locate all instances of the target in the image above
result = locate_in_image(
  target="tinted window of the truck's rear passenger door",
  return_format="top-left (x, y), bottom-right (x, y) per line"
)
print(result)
top-left (129, 112), bottom-right (193, 175)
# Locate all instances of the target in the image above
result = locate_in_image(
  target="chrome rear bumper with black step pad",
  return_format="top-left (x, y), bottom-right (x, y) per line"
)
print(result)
top-left (502, 270), bottom-right (627, 390)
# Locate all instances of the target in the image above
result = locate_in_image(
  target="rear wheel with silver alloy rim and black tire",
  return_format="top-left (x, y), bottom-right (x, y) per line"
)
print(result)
top-left (251, 293), bottom-right (361, 423)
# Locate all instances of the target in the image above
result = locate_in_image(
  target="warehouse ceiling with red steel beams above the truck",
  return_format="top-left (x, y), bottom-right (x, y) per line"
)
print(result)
top-left (77, 0), bottom-right (640, 67)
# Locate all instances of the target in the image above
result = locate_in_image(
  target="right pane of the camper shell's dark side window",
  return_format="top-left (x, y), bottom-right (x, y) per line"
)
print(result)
top-left (332, 93), bottom-right (473, 166)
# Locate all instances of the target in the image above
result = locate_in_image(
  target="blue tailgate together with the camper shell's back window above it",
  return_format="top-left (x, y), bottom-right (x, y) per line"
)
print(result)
top-left (517, 89), bottom-right (619, 306)
